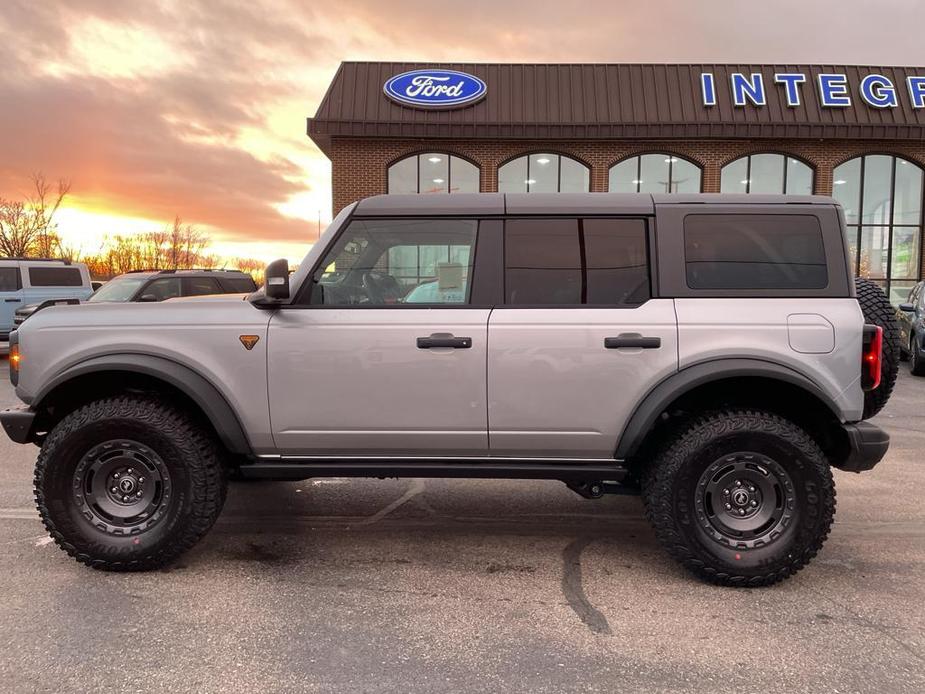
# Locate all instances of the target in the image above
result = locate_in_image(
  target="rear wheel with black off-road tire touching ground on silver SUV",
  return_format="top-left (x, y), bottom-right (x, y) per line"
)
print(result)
top-left (643, 410), bottom-right (835, 586)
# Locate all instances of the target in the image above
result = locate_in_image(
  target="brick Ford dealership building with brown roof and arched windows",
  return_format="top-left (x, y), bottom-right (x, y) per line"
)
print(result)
top-left (308, 63), bottom-right (925, 303)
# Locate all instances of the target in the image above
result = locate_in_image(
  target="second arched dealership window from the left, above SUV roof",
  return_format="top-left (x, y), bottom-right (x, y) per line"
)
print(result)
top-left (498, 154), bottom-right (591, 193)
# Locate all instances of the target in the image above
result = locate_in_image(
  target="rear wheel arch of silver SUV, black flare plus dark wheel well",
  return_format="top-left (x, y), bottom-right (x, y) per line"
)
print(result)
top-left (615, 358), bottom-right (847, 468)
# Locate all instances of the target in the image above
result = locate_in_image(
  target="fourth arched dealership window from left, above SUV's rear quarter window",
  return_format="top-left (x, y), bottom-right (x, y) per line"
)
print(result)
top-left (720, 154), bottom-right (813, 195)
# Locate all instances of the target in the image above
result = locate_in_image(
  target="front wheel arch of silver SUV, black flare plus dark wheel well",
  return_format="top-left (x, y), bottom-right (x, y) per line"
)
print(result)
top-left (31, 354), bottom-right (253, 456)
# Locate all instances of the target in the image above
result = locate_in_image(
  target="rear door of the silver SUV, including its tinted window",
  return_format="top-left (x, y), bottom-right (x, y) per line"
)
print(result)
top-left (488, 217), bottom-right (678, 459)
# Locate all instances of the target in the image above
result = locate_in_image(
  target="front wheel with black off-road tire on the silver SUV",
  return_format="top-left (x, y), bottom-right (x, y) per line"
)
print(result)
top-left (35, 395), bottom-right (226, 571)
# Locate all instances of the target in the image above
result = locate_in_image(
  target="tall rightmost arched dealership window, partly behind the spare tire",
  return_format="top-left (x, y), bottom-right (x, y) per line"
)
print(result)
top-left (832, 154), bottom-right (923, 304)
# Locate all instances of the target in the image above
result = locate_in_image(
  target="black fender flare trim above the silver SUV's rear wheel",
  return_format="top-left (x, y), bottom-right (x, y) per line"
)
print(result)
top-left (615, 357), bottom-right (843, 460)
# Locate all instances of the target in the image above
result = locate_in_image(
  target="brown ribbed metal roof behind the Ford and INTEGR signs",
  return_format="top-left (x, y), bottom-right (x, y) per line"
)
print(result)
top-left (308, 62), bottom-right (925, 149)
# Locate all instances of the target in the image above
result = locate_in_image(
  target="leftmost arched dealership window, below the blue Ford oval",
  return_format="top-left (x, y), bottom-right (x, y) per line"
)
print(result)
top-left (388, 152), bottom-right (479, 194)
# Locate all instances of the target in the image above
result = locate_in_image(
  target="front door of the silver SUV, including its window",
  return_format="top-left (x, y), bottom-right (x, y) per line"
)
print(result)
top-left (268, 218), bottom-right (490, 457)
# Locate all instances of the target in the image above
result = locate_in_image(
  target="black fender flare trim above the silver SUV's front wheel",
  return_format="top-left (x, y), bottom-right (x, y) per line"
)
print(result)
top-left (31, 353), bottom-right (253, 456)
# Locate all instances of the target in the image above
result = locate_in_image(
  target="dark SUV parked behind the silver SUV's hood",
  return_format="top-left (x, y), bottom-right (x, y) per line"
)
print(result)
top-left (13, 270), bottom-right (257, 327)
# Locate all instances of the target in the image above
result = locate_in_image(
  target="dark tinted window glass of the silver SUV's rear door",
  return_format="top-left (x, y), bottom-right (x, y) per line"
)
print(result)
top-left (504, 219), bottom-right (650, 306)
